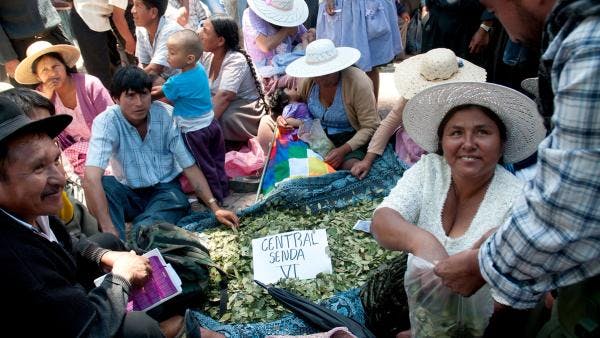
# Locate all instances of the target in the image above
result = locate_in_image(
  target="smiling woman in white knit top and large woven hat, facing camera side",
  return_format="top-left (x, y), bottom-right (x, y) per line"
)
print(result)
top-left (371, 82), bottom-right (545, 336)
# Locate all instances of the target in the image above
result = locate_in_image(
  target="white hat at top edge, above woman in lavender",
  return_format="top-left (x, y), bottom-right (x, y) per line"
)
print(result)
top-left (248, 0), bottom-right (308, 27)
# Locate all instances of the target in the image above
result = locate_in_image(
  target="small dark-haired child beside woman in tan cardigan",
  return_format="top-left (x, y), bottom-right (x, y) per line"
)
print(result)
top-left (271, 88), bottom-right (312, 140)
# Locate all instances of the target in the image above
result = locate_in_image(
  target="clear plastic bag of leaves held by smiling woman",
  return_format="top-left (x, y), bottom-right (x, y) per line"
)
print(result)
top-left (404, 255), bottom-right (493, 338)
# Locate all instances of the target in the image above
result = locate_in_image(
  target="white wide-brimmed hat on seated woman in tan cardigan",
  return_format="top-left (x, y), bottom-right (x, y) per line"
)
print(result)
top-left (285, 39), bottom-right (360, 77)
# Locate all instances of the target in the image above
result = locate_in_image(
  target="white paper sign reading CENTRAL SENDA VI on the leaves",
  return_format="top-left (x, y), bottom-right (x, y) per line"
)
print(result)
top-left (252, 229), bottom-right (333, 284)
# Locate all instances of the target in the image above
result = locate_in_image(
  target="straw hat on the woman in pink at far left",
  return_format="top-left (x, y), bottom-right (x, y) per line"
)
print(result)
top-left (15, 41), bottom-right (81, 84)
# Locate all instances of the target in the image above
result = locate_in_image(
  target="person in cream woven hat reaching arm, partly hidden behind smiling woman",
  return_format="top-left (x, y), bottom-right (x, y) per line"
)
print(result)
top-left (351, 48), bottom-right (486, 179)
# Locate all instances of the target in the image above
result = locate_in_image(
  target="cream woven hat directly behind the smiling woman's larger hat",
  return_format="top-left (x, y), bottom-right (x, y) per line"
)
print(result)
top-left (394, 48), bottom-right (486, 99)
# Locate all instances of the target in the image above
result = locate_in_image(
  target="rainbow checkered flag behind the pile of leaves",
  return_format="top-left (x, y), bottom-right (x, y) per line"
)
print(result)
top-left (262, 131), bottom-right (335, 194)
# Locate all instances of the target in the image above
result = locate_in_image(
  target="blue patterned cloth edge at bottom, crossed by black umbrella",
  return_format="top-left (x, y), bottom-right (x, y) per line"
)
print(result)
top-left (191, 288), bottom-right (365, 338)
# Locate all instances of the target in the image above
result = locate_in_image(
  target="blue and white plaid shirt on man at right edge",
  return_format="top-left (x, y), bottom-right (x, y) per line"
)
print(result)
top-left (478, 16), bottom-right (600, 308)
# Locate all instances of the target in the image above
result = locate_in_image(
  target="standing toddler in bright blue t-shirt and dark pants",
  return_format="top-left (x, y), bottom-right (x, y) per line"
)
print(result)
top-left (152, 29), bottom-right (229, 203)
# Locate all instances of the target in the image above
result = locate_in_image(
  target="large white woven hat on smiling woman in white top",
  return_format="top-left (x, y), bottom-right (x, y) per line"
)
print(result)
top-left (402, 82), bottom-right (546, 163)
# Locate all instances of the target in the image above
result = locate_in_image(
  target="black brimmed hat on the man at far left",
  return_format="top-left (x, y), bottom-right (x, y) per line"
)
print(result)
top-left (0, 97), bottom-right (73, 142)
